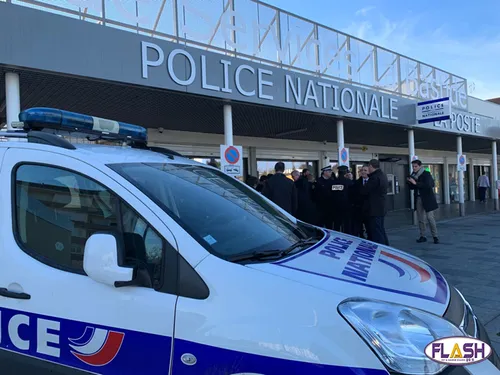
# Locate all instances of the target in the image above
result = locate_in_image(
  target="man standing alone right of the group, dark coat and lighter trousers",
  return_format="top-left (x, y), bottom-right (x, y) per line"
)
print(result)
top-left (407, 160), bottom-right (439, 244)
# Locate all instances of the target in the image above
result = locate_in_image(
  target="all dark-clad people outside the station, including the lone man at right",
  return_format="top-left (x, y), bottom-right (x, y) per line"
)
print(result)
top-left (247, 159), bottom-right (438, 245)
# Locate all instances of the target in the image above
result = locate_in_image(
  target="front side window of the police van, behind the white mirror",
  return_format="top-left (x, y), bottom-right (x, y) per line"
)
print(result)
top-left (15, 164), bottom-right (165, 287)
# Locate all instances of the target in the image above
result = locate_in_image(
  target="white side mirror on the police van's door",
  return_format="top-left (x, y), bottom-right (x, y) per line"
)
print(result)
top-left (83, 233), bottom-right (134, 287)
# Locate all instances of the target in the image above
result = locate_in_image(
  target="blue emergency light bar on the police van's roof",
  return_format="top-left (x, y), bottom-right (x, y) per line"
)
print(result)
top-left (13, 108), bottom-right (148, 142)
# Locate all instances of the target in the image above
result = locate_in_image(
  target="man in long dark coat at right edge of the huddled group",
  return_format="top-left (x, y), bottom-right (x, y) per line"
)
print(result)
top-left (361, 159), bottom-right (389, 245)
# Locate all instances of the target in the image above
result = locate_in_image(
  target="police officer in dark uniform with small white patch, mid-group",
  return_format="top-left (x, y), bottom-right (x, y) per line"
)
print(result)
top-left (333, 166), bottom-right (354, 234)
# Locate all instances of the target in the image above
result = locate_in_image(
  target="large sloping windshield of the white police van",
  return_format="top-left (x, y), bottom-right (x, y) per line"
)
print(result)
top-left (109, 163), bottom-right (322, 258)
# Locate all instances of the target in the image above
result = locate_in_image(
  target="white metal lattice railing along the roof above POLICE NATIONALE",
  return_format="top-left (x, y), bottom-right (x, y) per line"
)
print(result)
top-left (4, 0), bottom-right (468, 110)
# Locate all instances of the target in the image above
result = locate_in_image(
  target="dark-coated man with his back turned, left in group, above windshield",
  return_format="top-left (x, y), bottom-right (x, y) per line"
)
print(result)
top-left (262, 161), bottom-right (297, 215)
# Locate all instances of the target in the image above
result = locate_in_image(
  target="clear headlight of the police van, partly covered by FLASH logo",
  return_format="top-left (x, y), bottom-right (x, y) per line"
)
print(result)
top-left (338, 298), bottom-right (464, 375)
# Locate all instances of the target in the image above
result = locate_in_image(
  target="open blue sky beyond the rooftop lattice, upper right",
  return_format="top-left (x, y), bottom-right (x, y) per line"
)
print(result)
top-left (265, 0), bottom-right (500, 99)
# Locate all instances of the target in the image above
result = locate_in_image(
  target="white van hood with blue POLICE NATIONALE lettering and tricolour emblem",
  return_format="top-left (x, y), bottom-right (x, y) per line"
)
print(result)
top-left (249, 231), bottom-right (449, 315)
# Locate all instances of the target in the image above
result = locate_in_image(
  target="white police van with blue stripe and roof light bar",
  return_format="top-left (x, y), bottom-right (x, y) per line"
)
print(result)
top-left (0, 108), bottom-right (500, 375)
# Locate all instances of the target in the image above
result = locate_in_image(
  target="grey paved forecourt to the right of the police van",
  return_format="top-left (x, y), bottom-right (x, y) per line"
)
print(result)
top-left (387, 213), bottom-right (500, 353)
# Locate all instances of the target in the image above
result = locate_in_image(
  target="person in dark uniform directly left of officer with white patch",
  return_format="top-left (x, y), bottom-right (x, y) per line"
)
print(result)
top-left (314, 166), bottom-right (334, 229)
